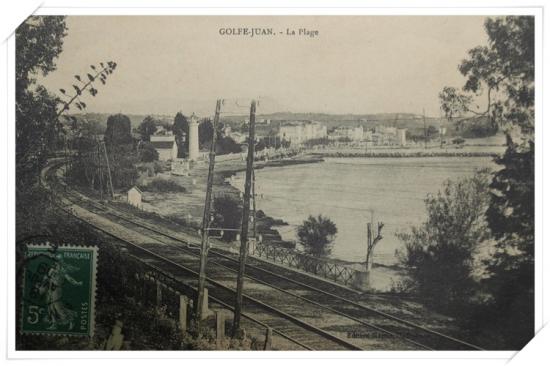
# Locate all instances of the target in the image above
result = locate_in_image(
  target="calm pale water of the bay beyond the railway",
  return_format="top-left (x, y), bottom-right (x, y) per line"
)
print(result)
top-left (232, 157), bottom-right (497, 265)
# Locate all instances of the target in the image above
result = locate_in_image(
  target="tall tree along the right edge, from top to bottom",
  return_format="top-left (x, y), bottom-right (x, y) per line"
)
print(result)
top-left (442, 16), bottom-right (535, 349)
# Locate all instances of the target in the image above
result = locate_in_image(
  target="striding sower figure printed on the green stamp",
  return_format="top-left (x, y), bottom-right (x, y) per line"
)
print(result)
top-left (39, 256), bottom-right (82, 330)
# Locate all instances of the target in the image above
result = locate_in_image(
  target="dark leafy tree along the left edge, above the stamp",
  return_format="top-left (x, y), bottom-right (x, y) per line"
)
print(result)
top-left (15, 16), bottom-right (67, 240)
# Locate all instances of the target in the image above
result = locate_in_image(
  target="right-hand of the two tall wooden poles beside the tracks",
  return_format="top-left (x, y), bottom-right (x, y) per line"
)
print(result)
top-left (233, 100), bottom-right (256, 337)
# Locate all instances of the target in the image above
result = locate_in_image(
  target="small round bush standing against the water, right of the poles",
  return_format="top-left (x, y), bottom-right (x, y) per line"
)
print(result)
top-left (297, 215), bottom-right (338, 257)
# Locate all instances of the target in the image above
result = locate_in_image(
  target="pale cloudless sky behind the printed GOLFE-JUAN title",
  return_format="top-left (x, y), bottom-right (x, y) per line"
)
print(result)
top-left (40, 16), bottom-right (487, 116)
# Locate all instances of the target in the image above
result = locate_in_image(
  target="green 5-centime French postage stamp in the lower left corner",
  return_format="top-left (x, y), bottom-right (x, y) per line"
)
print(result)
top-left (21, 245), bottom-right (98, 337)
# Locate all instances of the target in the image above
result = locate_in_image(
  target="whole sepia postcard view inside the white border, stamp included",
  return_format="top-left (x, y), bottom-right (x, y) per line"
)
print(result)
top-left (12, 13), bottom-right (539, 351)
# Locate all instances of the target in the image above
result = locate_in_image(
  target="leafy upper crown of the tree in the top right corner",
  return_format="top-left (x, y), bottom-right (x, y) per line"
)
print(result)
top-left (440, 16), bottom-right (535, 134)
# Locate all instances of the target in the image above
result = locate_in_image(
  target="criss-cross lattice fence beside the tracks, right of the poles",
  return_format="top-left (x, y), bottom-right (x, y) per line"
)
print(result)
top-left (250, 244), bottom-right (359, 285)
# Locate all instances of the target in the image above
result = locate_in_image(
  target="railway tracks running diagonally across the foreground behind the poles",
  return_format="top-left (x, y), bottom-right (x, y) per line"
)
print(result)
top-left (42, 160), bottom-right (480, 350)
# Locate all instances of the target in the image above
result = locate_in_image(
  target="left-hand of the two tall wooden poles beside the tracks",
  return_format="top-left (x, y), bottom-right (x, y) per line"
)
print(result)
top-left (195, 99), bottom-right (222, 333)
